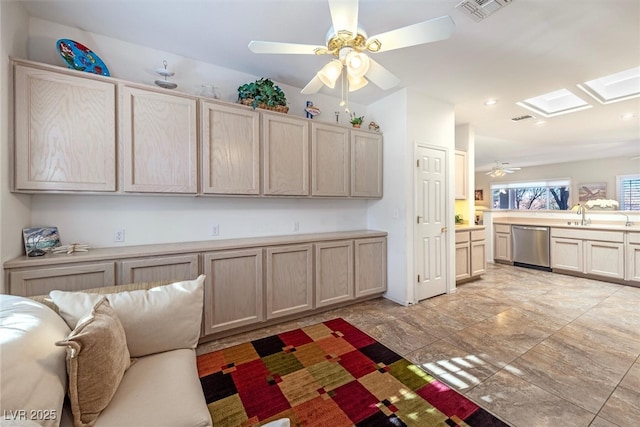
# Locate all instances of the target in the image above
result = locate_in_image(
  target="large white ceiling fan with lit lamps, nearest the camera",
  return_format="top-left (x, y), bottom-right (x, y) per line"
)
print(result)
top-left (249, 0), bottom-right (455, 94)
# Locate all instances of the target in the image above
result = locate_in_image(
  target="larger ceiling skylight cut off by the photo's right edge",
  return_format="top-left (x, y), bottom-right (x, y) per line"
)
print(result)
top-left (578, 67), bottom-right (640, 104)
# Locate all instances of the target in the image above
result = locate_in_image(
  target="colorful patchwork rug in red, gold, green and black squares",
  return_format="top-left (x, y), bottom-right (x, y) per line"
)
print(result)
top-left (198, 319), bottom-right (507, 427)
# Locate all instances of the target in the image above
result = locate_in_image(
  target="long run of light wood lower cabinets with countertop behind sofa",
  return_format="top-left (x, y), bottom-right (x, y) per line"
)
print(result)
top-left (4, 230), bottom-right (387, 340)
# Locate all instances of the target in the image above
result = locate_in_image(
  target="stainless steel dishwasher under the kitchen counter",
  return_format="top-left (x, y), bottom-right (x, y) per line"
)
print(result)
top-left (511, 225), bottom-right (551, 270)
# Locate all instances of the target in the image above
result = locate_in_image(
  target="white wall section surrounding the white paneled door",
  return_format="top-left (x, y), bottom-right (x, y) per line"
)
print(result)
top-left (368, 89), bottom-right (455, 305)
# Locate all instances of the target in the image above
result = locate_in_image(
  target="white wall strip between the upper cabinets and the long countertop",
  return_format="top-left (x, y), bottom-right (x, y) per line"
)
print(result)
top-left (31, 195), bottom-right (370, 247)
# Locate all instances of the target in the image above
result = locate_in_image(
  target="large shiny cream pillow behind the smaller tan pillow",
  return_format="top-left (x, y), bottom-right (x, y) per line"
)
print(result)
top-left (49, 275), bottom-right (205, 357)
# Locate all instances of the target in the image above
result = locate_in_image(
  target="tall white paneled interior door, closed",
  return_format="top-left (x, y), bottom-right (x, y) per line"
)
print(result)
top-left (415, 145), bottom-right (447, 301)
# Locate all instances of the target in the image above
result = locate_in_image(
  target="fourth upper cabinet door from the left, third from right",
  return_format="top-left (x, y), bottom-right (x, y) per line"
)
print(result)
top-left (262, 113), bottom-right (309, 196)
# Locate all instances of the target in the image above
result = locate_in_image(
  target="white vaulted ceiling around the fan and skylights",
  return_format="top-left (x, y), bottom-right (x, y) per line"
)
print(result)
top-left (21, 0), bottom-right (640, 171)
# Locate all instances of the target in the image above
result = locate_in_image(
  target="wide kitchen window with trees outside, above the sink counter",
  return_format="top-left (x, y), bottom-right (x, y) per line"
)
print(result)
top-left (491, 179), bottom-right (571, 210)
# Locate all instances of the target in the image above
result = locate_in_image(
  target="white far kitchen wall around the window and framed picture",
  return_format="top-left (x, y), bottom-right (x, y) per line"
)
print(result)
top-left (475, 157), bottom-right (640, 211)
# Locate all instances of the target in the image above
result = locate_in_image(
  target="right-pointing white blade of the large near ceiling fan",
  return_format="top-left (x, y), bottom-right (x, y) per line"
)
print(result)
top-left (368, 15), bottom-right (455, 52)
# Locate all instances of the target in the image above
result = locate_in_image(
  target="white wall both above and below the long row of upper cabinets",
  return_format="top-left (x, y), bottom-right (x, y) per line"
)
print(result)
top-left (15, 18), bottom-right (372, 251)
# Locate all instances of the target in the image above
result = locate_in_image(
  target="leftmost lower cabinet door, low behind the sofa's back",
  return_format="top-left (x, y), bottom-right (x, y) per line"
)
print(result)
top-left (9, 262), bottom-right (116, 296)
